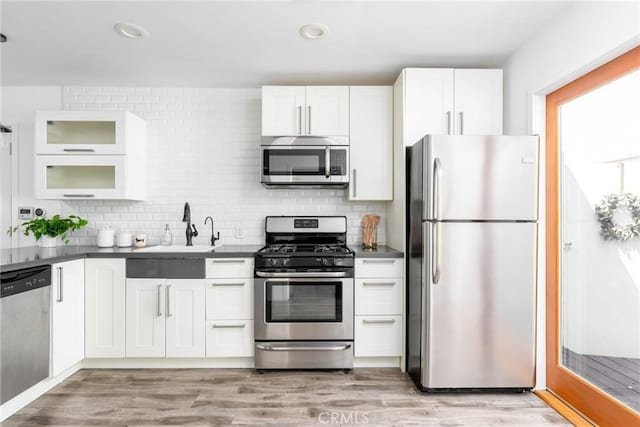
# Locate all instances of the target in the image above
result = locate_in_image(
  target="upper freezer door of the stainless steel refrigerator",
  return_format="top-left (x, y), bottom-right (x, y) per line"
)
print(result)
top-left (423, 135), bottom-right (538, 221)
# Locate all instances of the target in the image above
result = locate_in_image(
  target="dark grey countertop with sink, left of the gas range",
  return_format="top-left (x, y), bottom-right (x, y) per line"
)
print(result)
top-left (0, 245), bottom-right (262, 271)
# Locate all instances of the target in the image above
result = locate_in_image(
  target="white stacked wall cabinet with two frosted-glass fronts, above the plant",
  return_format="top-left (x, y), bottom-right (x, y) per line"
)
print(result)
top-left (35, 111), bottom-right (146, 200)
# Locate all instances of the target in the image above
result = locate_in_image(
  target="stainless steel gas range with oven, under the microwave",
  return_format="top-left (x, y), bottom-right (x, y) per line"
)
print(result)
top-left (254, 216), bottom-right (354, 370)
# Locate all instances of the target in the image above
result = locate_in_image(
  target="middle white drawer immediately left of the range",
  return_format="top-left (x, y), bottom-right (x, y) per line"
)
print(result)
top-left (207, 279), bottom-right (253, 319)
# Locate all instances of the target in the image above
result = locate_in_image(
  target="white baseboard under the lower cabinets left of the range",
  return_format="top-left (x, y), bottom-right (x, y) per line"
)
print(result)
top-left (82, 357), bottom-right (255, 369)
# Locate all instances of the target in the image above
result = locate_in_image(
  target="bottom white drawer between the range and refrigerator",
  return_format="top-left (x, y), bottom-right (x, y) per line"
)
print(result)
top-left (354, 316), bottom-right (402, 357)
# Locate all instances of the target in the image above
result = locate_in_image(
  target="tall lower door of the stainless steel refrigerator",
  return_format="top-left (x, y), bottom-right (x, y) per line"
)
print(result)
top-left (422, 222), bottom-right (537, 389)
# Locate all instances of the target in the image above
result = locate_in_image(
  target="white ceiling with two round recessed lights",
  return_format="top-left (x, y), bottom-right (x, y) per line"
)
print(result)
top-left (1, 1), bottom-right (570, 87)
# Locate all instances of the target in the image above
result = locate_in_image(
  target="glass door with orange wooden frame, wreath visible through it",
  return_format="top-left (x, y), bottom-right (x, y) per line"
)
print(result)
top-left (547, 48), bottom-right (640, 425)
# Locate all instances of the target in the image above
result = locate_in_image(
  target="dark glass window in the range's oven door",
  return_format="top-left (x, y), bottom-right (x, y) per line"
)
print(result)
top-left (265, 280), bottom-right (342, 323)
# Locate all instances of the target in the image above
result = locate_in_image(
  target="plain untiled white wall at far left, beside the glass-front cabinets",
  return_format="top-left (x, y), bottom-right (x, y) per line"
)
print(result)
top-left (0, 86), bottom-right (62, 246)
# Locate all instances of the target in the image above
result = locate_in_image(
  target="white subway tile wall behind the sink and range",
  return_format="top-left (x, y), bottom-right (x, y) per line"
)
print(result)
top-left (6, 87), bottom-right (385, 245)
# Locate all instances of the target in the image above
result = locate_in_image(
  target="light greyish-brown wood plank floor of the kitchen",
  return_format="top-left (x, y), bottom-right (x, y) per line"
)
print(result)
top-left (2, 369), bottom-right (570, 426)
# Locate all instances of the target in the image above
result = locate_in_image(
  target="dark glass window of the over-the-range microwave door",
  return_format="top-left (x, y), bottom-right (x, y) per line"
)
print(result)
top-left (262, 148), bottom-right (325, 175)
